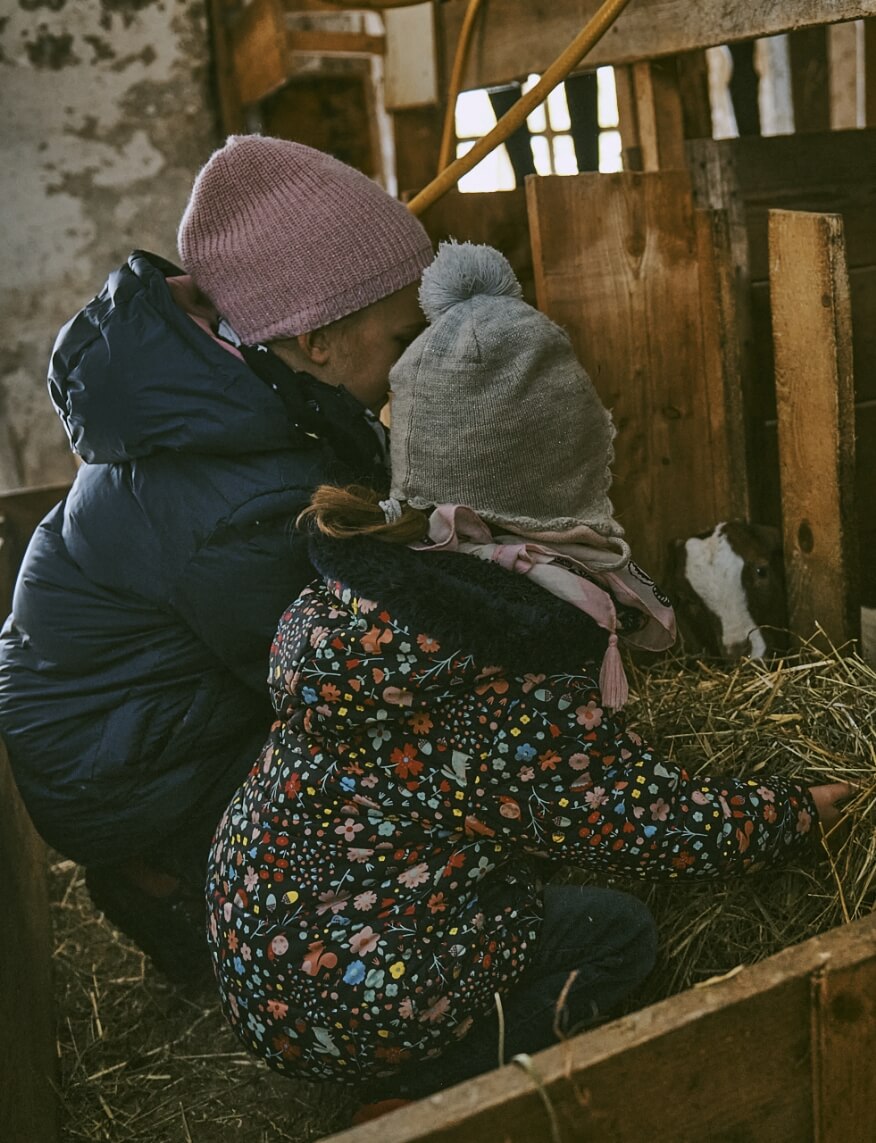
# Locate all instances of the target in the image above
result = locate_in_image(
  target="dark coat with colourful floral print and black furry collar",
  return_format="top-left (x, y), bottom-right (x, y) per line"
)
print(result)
top-left (208, 538), bottom-right (814, 1084)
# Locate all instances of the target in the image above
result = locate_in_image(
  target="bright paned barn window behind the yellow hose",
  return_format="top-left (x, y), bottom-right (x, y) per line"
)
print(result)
top-left (456, 67), bottom-right (622, 191)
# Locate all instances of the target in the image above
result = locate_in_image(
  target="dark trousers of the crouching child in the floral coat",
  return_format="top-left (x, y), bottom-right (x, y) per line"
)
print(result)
top-left (377, 885), bottom-right (656, 1100)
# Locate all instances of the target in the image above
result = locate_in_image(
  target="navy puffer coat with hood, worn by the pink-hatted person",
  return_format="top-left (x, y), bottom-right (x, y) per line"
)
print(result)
top-left (0, 253), bottom-right (384, 863)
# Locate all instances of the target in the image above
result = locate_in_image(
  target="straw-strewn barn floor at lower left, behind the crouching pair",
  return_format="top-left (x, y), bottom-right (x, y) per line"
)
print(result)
top-left (49, 857), bottom-right (361, 1143)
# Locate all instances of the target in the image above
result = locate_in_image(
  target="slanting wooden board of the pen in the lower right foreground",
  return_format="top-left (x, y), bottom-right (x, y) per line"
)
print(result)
top-left (326, 914), bottom-right (876, 1143)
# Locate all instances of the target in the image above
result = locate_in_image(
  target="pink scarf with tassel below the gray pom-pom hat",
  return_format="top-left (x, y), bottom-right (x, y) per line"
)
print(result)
top-left (412, 504), bottom-right (676, 710)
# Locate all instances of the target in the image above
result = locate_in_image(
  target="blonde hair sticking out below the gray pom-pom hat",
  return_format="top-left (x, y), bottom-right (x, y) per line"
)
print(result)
top-left (295, 485), bottom-right (429, 544)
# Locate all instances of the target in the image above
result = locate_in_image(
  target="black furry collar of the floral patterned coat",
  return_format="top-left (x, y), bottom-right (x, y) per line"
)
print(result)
top-left (310, 534), bottom-right (608, 674)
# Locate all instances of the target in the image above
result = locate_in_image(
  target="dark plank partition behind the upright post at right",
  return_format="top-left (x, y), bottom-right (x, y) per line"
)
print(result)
top-left (687, 129), bottom-right (876, 602)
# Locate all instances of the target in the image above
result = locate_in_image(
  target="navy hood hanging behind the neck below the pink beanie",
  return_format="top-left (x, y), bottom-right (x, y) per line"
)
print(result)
top-left (49, 250), bottom-right (289, 464)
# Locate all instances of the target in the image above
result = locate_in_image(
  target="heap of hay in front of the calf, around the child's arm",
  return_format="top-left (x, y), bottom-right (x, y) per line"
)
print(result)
top-left (583, 646), bottom-right (876, 1002)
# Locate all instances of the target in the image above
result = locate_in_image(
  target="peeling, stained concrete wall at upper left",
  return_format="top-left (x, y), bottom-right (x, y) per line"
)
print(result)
top-left (0, 0), bottom-right (217, 490)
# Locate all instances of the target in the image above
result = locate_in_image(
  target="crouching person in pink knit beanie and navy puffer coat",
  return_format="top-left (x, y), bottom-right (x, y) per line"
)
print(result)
top-left (0, 135), bottom-right (432, 981)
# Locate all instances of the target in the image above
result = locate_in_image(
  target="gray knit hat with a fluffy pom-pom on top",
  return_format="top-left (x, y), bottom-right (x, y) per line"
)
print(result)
top-left (390, 242), bottom-right (623, 536)
